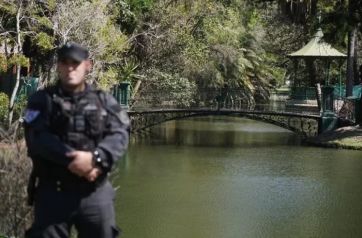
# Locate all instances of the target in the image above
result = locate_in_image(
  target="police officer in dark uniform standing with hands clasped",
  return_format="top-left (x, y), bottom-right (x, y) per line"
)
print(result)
top-left (24, 43), bottom-right (129, 238)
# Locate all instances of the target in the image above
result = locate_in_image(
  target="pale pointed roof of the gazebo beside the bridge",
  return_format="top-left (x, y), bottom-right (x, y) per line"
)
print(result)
top-left (288, 28), bottom-right (347, 58)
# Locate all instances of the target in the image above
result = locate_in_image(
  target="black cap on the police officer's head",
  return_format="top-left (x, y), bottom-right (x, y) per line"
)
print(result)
top-left (57, 42), bottom-right (89, 62)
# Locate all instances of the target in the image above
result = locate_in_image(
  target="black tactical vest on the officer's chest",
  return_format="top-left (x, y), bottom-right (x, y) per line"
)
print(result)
top-left (49, 86), bottom-right (107, 151)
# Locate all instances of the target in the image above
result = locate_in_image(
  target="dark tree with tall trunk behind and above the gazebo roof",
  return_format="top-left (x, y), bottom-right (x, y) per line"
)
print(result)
top-left (259, 0), bottom-right (362, 96)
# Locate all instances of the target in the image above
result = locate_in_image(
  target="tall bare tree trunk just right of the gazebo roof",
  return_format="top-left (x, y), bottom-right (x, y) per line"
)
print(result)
top-left (346, 27), bottom-right (358, 97)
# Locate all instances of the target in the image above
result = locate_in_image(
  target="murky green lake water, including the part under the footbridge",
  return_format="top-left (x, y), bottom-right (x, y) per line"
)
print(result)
top-left (114, 117), bottom-right (362, 238)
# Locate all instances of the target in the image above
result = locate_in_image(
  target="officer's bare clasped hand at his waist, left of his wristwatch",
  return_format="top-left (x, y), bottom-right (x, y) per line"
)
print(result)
top-left (66, 150), bottom-right (93, 177)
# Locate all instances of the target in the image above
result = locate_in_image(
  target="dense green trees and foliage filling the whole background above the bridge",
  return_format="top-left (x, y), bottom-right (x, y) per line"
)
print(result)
top-left (0, 0), bottom-right (361, 124)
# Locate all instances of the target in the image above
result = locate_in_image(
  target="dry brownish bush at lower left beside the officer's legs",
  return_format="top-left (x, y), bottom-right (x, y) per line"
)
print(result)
top-left (0, 128), bottom-right (32, 237)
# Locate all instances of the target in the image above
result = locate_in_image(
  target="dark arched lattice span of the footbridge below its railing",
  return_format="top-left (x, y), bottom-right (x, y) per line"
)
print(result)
top-left (129, 108), bottom-right (322, 137)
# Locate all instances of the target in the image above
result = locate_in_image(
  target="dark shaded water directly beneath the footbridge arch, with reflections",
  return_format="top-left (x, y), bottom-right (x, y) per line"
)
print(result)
top-left (136, 117), bottom-right (300, 147)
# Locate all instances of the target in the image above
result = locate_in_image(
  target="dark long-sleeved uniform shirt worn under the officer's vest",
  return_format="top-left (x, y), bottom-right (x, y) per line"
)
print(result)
top-left (24, 85), bottom-right (129, 181)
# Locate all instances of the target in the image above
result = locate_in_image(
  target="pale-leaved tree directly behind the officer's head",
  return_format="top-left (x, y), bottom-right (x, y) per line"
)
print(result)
top-left (51, 0), bottom-right (128, 88)
